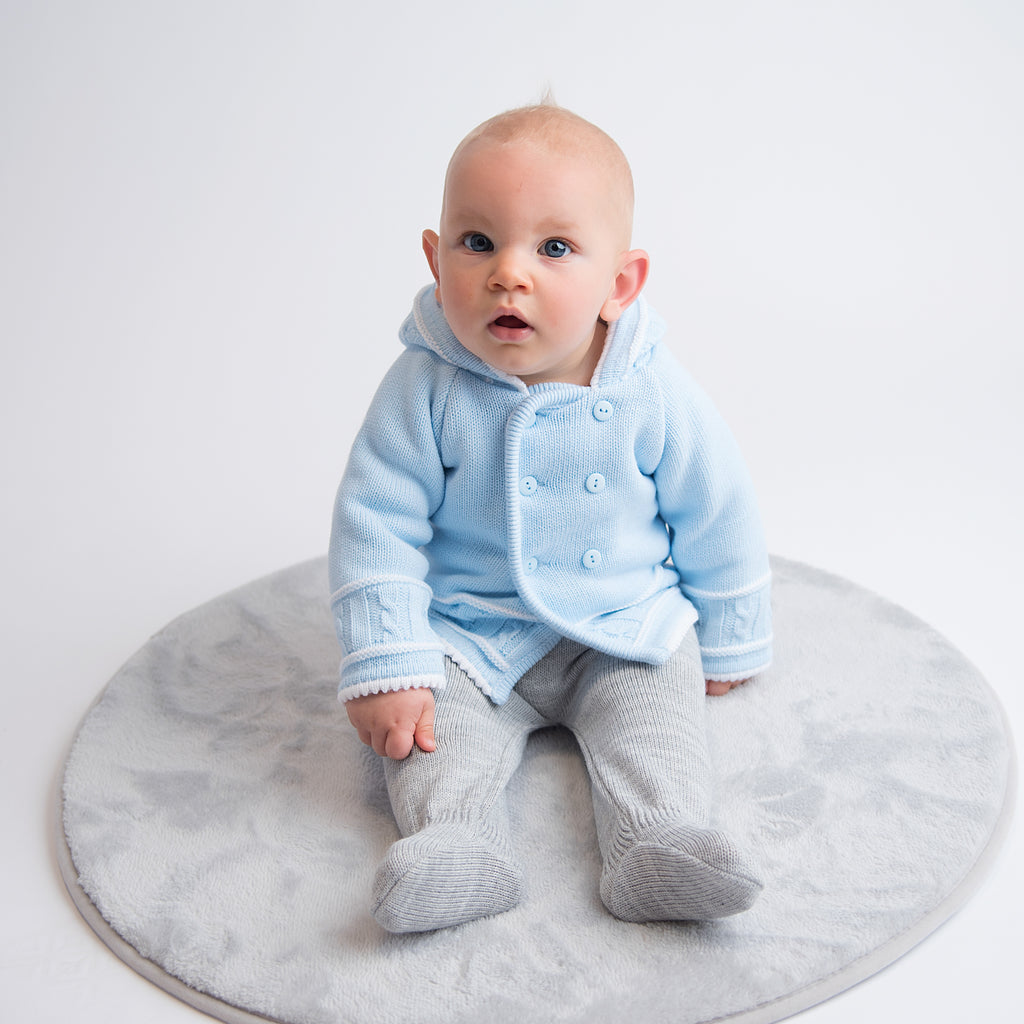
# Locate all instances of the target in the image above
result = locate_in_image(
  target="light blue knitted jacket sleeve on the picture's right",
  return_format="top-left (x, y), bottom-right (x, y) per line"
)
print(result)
top-left (654, 349), bottom-right (772, 681)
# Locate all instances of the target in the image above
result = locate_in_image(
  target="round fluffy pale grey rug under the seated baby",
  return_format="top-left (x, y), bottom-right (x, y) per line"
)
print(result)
top-left (60, 559), bottom-right (1015, 1024)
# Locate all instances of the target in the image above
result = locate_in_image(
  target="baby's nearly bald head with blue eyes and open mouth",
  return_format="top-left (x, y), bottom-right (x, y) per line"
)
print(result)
top-left (423, 104), bottom-right (648, 384)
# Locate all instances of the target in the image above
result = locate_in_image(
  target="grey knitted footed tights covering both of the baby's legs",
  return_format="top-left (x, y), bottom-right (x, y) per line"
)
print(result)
top-left (373, 630), bottom-right (761, 932)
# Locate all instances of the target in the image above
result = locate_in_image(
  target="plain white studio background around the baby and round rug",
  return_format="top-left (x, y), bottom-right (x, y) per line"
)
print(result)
top-left (0, 0), bottom-right (1024, 1024)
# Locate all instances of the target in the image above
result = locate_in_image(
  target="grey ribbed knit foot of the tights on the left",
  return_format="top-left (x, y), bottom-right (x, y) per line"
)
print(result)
top-left (373, 824), bottom-right (522, 932)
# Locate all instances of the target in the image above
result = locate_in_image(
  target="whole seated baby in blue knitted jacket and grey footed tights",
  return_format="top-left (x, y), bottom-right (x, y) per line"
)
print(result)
top-left (330, 104), bottom-right (771, 932)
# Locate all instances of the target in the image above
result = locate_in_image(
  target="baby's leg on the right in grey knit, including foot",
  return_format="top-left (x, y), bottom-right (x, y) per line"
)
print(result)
top-left (566, 631), bottom-right (762, 921)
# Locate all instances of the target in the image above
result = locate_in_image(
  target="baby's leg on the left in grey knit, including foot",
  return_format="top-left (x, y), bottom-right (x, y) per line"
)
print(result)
top-left (373, 662), bottom-right (542, 932)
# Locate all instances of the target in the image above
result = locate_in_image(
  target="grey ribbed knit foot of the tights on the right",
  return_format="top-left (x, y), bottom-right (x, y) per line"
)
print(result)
top-left (601, 825), bottom-right (762, 922)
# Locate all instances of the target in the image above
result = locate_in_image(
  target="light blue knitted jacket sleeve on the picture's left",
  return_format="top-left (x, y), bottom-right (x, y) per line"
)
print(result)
top-left (328, 352), bottom-right (450, 700)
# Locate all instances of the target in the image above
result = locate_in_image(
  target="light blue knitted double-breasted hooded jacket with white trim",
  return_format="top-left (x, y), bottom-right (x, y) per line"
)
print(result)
top-left (329, 286), bottom-right (771, 703)
